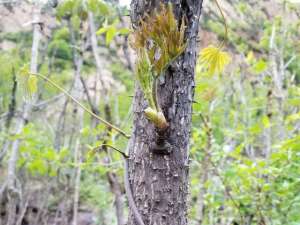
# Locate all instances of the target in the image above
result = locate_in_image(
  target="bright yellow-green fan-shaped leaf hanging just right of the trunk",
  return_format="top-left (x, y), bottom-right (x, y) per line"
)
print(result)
top-left (200, 45), bottom-right (231, 75)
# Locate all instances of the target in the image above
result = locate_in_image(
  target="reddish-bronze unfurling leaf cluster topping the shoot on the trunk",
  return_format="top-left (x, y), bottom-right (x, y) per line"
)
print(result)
top-left (131, 4), bottom-right (186, 75)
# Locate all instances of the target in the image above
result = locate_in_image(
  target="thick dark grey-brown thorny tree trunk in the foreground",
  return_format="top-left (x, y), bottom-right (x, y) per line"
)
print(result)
top-left (129, 0), bottom-right (202, 225)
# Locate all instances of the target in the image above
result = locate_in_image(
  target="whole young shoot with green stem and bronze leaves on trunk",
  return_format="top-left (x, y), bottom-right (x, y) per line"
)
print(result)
top-left (131, 4), bottom-right (186, 129)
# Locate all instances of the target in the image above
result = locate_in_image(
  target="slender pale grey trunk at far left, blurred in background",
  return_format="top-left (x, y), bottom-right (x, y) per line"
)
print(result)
top-left (7, 6), bottom-right (41, 225)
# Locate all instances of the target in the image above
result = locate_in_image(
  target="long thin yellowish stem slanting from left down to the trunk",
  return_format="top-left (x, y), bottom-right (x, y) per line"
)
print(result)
top-left (30, 73), bottom-right (130, 139)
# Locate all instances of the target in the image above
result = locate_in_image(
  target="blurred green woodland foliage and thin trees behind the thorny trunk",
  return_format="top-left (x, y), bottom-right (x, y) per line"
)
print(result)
top-left (0, 0), bottom-right (300, 225)
